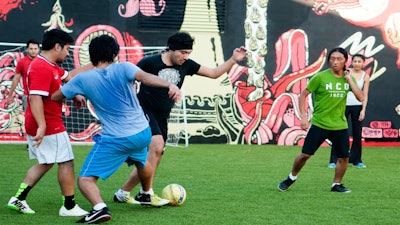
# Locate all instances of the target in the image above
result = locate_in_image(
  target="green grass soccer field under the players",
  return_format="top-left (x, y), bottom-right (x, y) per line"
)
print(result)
top-left (0, 144), bottom-right (400, 225)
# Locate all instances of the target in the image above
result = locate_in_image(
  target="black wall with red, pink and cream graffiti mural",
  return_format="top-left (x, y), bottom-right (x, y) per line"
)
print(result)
top-left (0, 0), bottom-right (400, 145)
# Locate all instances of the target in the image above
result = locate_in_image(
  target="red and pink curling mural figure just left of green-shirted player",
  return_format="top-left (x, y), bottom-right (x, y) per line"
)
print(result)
top-left (229, 29), bottom-right (326, 145)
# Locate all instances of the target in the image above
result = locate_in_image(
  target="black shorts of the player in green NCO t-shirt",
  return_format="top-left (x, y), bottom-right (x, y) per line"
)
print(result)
top-left (301, 125), bottom-right (350, 158)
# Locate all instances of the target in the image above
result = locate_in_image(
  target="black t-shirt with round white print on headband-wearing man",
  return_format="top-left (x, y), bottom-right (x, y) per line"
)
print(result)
top-left (137, 54), bottom-right (200, 118)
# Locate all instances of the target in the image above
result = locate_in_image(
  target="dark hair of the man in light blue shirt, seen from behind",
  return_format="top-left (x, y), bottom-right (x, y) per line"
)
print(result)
top-left (89, 34), bottom-right (119, 66)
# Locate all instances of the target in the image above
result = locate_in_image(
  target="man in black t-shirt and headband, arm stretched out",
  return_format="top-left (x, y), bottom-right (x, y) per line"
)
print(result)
top-left (114, 32), bottom-right (247, 204)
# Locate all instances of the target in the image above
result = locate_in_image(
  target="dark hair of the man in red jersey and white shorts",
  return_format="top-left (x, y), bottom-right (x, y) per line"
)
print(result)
top-left (42, 29), bottom-right (74, 51)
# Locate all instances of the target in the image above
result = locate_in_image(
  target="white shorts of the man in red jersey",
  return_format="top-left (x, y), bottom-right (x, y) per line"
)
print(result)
top-left (26, 131), bottom-right (74, 164)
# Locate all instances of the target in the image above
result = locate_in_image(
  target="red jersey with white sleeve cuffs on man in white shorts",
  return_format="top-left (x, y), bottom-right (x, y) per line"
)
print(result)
top-left (25, 55), bottom-right (68, 136)
